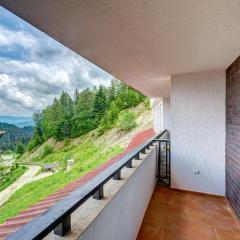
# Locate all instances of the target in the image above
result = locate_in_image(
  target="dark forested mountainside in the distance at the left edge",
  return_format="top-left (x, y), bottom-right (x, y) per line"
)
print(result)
top-left (0, 122), bottom-right (34, 150)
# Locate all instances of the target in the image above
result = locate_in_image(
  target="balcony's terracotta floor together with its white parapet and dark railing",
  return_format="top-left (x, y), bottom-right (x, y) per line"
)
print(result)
top-left (0, 131), bottom-right (240, 240)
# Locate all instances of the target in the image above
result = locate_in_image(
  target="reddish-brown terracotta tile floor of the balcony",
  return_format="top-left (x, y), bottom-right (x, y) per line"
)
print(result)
top-left (137, 186), bottom-right (240, 240)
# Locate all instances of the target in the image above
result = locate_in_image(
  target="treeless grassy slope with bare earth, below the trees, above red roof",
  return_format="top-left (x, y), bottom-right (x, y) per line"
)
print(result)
top-left (0, 104), bottom-right (152, 223)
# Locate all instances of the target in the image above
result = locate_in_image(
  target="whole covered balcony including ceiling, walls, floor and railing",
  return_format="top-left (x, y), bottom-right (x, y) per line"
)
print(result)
top-left (0, 0), bottom-right (240, 240)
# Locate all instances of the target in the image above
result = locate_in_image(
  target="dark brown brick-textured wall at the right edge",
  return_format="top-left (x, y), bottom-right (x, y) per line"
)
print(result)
top-left (226, 57), bottom-right (240, 217)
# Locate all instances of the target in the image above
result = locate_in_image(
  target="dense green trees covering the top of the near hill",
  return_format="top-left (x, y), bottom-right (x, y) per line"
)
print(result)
top-left (28, 79), bottom-right (146, 151)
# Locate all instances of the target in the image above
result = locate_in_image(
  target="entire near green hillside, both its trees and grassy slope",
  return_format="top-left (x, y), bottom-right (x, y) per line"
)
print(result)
top-left (0, 80), bottom-right (154, 223)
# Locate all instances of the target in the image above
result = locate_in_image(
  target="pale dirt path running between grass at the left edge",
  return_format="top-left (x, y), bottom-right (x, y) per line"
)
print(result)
top-left (0, 166), bottom-right (40, 206)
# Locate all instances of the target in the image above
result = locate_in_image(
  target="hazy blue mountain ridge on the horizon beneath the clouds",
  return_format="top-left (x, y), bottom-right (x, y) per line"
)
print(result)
top-left (0, 115), bottom-right (34, 128)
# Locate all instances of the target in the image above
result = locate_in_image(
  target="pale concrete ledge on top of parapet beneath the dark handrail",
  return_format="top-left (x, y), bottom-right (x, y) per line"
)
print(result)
top-left (44, 144), bottom-right (156, 240)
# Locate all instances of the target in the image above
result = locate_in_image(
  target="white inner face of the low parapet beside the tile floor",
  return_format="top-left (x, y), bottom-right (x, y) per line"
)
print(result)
top-left (80, 148), bottom-right (156, 240)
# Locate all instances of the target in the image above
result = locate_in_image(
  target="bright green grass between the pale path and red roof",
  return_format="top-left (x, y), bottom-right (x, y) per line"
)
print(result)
top-left (0, 141), bottom-right (122, 223)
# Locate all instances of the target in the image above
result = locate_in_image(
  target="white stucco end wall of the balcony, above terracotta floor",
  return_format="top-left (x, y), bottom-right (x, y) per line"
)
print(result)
top-left (171, 71), bottom-right (225, 195)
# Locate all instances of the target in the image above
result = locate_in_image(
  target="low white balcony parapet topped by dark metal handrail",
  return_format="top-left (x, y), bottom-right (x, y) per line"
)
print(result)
top-left (3, 131), bottom-right (167, 239)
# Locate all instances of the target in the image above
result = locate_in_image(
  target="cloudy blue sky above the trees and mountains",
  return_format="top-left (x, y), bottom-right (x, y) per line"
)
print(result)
top-left (0, 6), bottom-right (113, 116)
